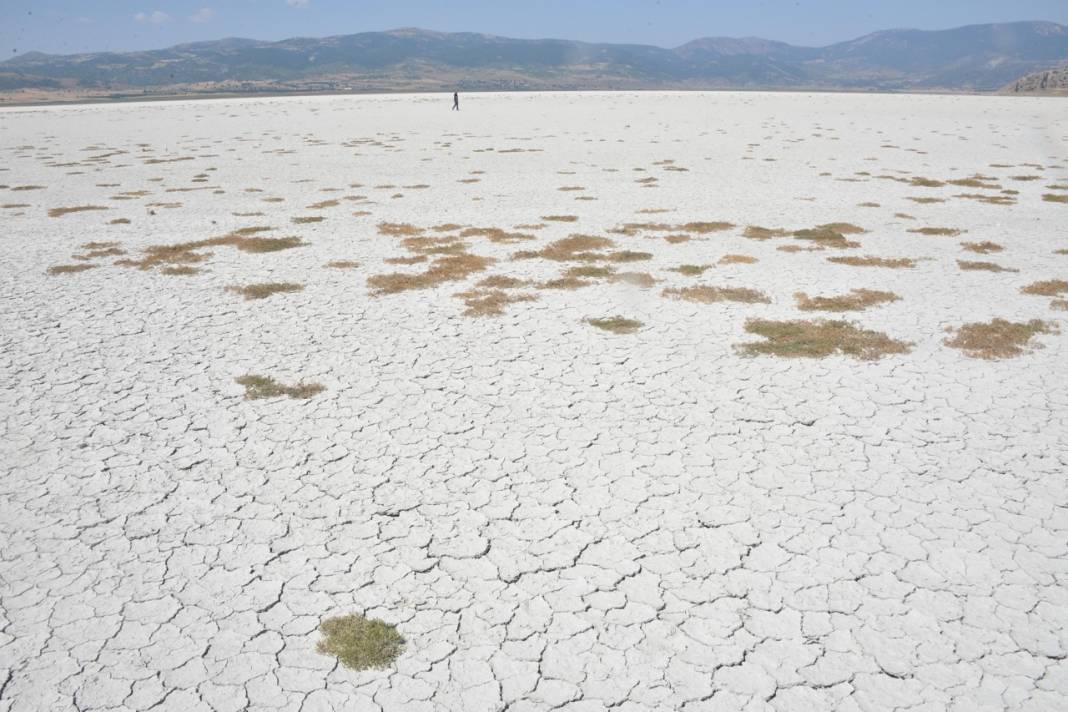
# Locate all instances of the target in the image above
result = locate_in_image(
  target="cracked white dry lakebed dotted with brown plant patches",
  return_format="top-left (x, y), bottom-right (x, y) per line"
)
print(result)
top-left (0, 93), bottom-right (1068, 712)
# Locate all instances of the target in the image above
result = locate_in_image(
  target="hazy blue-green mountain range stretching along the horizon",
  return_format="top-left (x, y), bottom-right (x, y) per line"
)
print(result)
top-left (0, 22), bottom-right (1068, 101)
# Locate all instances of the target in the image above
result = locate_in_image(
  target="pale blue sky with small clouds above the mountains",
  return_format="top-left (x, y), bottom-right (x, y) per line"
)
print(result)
top-left (0, 0), bottom-right (1068, 58)
